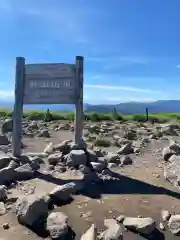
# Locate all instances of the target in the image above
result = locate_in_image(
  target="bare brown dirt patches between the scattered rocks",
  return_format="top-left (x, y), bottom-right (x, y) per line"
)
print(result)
top-left (0, 128), bottom-right (180, 240)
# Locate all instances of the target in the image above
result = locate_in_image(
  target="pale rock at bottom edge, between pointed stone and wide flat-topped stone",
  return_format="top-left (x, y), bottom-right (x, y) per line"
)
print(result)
top-left (100, 219), bottom-right (123, 240)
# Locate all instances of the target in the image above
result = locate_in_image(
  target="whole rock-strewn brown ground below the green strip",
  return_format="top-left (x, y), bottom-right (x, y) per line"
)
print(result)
top-left (0, 120), bottom-right (180, 240)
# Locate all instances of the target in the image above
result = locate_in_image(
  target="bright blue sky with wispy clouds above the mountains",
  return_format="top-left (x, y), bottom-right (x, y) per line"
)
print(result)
top-left (0, 0), bottom-right (180, 103)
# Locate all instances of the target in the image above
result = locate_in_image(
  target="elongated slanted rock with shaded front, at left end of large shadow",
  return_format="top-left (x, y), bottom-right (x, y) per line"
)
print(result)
top-left (49, 181), bottom-right (84, 202)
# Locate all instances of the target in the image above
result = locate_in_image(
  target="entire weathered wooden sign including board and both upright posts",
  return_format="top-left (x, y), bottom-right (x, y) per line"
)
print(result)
top-left (13, 56), bottom-right (84, 157)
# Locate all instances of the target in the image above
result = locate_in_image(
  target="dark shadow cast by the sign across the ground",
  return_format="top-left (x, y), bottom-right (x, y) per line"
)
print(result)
top-left (36, 171), bottom-right (180, 199)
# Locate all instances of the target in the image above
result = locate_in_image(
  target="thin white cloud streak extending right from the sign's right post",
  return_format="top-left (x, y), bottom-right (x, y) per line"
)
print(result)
top-left (84, 84), bottom-right (160, 93)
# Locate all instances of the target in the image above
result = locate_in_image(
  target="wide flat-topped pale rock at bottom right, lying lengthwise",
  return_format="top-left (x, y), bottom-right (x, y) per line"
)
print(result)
top-left (123, 217), bottom-right (156, 235)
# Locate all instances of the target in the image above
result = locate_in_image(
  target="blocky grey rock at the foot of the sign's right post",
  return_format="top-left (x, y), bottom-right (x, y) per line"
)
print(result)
top-left (67, 150), bottom-right (87, 167)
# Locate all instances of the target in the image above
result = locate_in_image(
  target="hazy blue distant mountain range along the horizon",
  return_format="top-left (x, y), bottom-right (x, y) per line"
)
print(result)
top-left (0, 100), bottom-right (180, 114)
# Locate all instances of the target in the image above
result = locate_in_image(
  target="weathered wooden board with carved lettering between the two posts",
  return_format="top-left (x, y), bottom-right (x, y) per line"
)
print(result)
top-left (24, 63), bottom-right (76, 104)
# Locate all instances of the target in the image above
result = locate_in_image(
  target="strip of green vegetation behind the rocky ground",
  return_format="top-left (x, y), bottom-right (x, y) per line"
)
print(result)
top-left (0, 109), bottom-right (180, 122)
